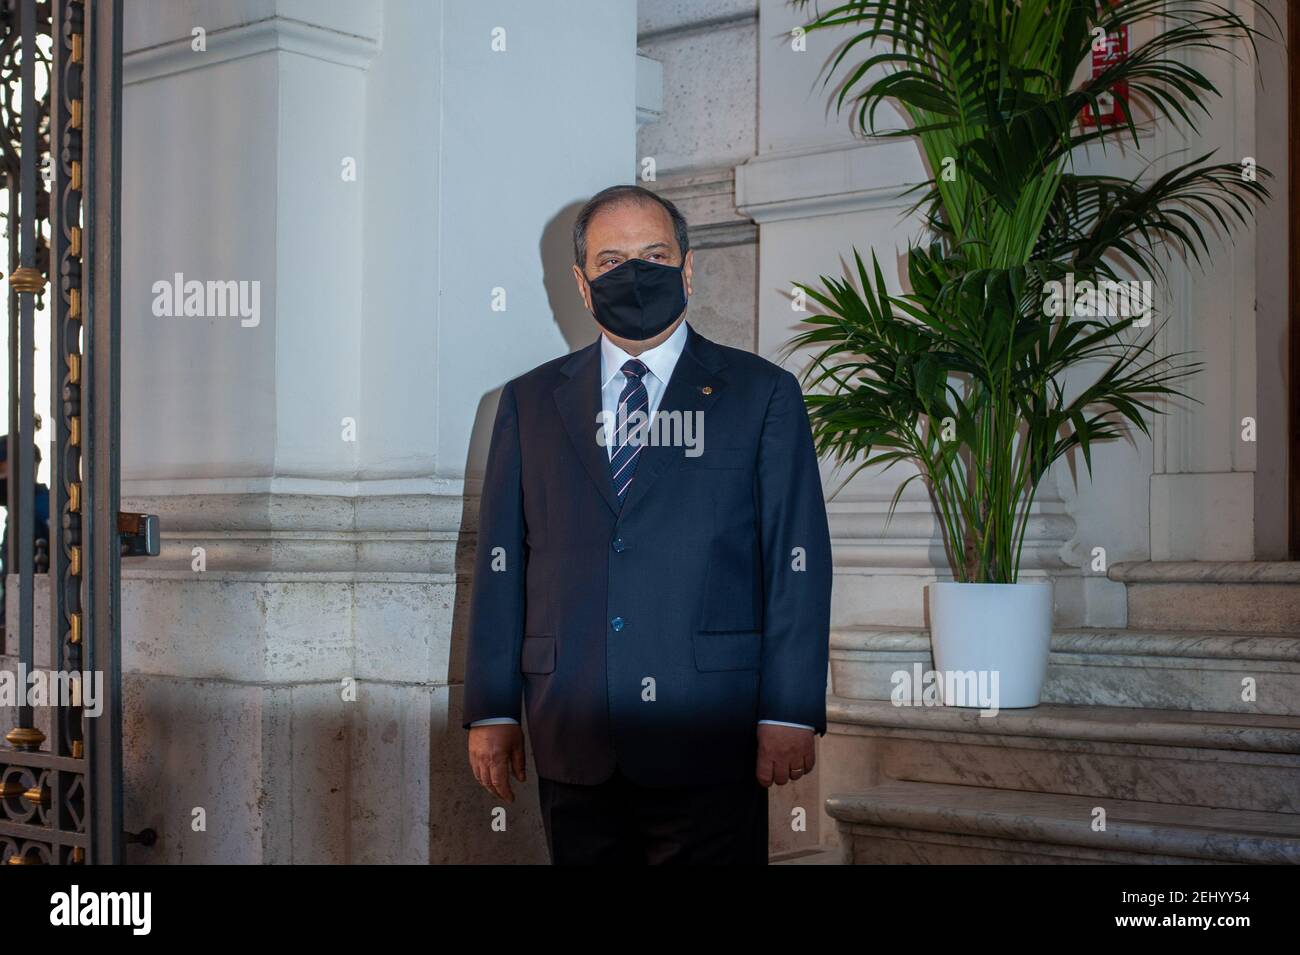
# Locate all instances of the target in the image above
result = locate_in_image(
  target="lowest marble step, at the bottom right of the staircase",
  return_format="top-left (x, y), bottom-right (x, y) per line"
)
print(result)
top-left (826, 781), bottom-right (1300, 865)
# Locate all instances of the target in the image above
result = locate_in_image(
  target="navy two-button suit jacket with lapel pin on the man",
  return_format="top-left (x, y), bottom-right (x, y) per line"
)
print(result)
top-left (463, 324), bottom-right (831, 786)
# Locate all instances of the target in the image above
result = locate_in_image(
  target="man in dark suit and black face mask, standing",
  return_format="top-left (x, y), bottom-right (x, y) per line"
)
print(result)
top-left (464, 186), bottom-right (831, 864)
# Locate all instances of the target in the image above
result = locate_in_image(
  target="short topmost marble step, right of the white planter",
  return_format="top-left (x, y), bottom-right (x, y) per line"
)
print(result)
top-left (1106, 560), bottom-right (1300, 635)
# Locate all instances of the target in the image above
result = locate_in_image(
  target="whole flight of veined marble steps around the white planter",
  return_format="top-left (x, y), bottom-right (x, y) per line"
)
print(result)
top-left (819, 564), bottom-right (1300, 864)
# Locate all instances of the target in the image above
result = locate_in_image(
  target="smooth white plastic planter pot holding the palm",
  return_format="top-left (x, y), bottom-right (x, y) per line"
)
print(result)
top-left (930, 581), bottom-right (1052, 709)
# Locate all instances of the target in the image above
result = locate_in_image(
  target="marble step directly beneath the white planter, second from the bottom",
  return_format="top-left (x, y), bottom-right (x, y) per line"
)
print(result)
top-left (818, 696), bottom-right (1300, 813)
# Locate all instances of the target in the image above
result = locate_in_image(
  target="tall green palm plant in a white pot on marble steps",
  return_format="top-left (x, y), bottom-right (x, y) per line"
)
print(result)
top-left (788, 0), bottom-right (1275, 707)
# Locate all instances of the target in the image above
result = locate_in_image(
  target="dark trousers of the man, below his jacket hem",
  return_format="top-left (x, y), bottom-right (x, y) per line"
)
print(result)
top-left (537, 769), bottom-right (767, 865)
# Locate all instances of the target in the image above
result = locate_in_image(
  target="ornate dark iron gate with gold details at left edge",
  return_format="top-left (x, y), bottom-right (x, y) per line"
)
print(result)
top-left (0, 0), bottom-right (122, 864)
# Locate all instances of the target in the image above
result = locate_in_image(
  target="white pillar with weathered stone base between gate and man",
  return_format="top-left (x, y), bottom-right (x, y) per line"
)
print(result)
top-left (122, 0), bottom-right (637, 863)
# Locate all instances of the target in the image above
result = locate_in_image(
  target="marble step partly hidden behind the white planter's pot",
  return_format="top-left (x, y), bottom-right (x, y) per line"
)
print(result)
top-left (831, 628), bottom-right (1300, 716)
